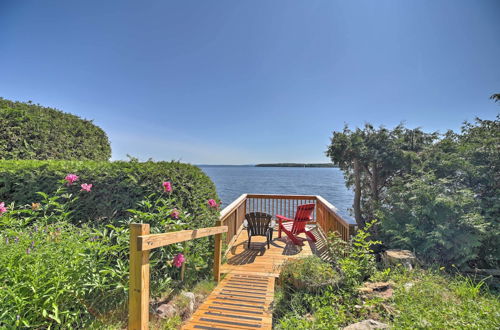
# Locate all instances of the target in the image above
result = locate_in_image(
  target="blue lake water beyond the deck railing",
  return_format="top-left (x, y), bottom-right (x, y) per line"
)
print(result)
top-left (199, 165), bottom-right (354, 223)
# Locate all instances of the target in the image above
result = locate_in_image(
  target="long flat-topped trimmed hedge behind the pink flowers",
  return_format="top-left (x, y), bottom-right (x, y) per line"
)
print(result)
top-left (0, 160), bottom-right (217, 224)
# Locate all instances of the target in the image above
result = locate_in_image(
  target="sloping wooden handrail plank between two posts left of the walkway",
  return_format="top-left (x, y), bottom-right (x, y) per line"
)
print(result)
top-left (137, 226), bottom-right (228, 251)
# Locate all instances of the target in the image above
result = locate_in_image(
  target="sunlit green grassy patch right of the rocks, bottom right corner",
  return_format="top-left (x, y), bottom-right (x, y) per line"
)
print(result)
top-left (391, 271), bottom-right (500, 329)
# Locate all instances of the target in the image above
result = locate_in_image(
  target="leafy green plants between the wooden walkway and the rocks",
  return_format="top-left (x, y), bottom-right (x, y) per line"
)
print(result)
top-left (274, 227), bottom-right (379, 329)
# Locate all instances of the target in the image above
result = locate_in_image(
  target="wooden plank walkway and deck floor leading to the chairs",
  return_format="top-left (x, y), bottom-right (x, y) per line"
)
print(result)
top-left (182, 226), bottom-right (323, 330)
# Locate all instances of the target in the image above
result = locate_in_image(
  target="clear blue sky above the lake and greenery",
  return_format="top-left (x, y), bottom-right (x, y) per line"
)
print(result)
top-left (0, 0), bottom-right (500, 164)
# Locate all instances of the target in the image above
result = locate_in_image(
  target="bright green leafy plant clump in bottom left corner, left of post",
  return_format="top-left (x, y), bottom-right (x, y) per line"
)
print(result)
top-left (0, 223), bottom-right (127, 328)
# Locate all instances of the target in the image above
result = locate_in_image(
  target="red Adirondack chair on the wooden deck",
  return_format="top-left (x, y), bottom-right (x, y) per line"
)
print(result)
top-left (276, 204), bottom-right (316, 245)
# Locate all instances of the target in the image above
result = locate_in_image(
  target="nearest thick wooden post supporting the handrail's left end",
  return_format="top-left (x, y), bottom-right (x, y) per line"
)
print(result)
top-left (128, 223), bottom-right (149, 330)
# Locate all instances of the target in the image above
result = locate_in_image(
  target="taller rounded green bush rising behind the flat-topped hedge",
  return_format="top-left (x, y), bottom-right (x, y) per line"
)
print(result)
top-left (0, 98), bottom-right (111, 160)
